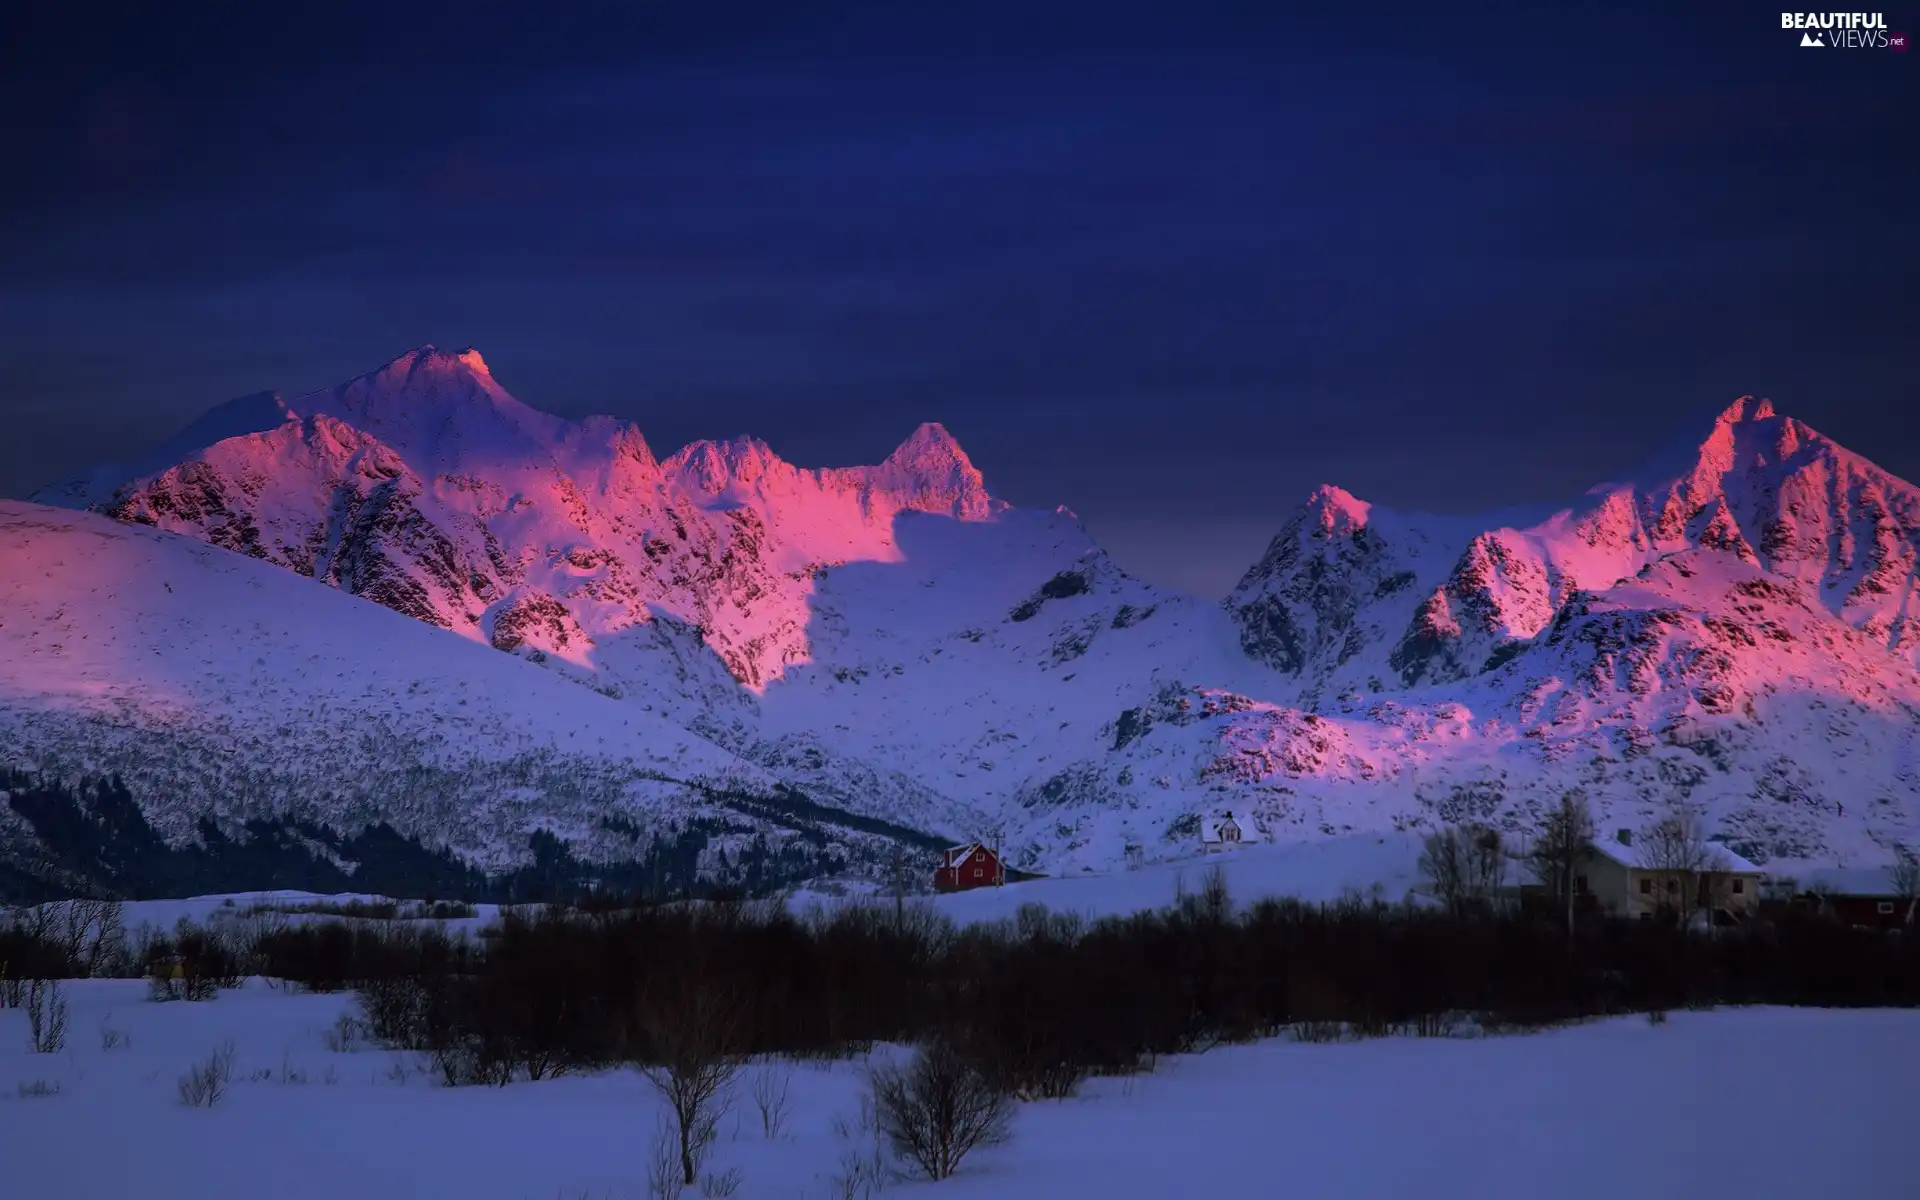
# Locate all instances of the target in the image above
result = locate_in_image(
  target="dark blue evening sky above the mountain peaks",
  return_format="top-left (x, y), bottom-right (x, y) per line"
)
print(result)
top-left (0, 0), bottom-right (1920, 593)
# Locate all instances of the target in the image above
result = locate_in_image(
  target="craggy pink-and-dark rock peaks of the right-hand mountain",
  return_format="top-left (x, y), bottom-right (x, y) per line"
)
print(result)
top-left (1227, 397), bottom-right (1920, 689)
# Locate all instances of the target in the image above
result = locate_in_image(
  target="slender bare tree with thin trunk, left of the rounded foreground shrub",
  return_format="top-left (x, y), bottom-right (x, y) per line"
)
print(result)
top-left (636, 979), bottom-right (747, 1187)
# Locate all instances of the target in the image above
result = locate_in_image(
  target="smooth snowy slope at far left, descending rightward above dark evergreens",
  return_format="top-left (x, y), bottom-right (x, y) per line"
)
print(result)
top-left (0, 501), bottom-right (929, 864)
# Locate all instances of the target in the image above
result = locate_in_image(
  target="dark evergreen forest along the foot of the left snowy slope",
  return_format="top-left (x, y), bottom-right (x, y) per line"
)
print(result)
top-left (0, 770), bottom-right (913, 904)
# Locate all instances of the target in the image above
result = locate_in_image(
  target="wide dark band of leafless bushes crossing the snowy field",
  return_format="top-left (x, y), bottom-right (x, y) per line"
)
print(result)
top-left (236, 879), bottom-right (1920, 1096)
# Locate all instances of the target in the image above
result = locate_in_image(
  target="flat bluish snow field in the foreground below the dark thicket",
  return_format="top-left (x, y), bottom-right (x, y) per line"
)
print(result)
top-left (0, 981), bottom-right (1920, 1200)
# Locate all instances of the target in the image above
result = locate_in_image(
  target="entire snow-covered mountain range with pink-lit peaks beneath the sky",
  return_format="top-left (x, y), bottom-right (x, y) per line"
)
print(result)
top-left (15, 348), bottom-right (1920, 890)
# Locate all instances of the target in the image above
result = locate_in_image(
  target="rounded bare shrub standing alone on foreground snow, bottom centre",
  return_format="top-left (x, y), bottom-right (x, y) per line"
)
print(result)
top-left (870, 1039), bottom-right (1014, 1179)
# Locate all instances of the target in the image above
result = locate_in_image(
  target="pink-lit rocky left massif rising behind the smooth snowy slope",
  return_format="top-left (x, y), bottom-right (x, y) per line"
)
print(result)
top-left (61, 348), bottom-right (1004, 689)
